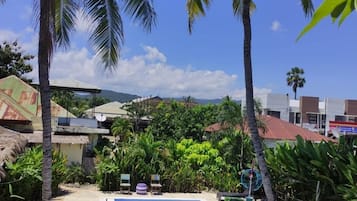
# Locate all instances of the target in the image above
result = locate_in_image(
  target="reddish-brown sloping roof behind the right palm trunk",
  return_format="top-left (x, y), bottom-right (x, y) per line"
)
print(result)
top-left (205, 115), bottom-right (336, 142)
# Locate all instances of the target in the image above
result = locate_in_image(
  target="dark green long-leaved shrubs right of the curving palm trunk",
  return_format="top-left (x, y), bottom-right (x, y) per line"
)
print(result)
top-left (266, 136), bottom-right (357, 200)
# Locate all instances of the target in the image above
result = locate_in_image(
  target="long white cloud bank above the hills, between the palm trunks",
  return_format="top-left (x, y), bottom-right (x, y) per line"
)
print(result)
top-left (44, 46), bottom-right (245, 98)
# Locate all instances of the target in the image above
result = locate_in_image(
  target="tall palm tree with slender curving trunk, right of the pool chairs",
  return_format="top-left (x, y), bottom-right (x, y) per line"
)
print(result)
top-left (186, 0), bottom-right (313, 201)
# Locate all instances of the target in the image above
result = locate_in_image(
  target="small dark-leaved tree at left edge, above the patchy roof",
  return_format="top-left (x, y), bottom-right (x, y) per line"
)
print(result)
top-left (0, 41), bottom-right (34, 83)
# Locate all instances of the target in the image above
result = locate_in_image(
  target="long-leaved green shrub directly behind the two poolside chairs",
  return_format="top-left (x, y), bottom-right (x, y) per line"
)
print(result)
top-left (95, 133), bottom-right (165, 190)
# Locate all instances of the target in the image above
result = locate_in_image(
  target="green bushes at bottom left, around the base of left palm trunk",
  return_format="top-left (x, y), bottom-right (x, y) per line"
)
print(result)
top-left (0, 146), bottom-right (67, 201)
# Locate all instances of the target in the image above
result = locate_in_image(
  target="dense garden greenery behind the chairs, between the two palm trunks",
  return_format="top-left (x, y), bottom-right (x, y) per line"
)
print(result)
top-left (92, 99), bottom-right (253, 192)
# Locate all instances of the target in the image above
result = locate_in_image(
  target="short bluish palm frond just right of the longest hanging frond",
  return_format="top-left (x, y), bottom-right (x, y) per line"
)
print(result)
top-left (124, 0), bottom-right (156, 31)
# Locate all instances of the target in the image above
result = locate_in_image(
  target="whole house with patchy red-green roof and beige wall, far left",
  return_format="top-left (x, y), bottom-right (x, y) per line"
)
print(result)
top-left (0, 76), bottom-right (109, 164)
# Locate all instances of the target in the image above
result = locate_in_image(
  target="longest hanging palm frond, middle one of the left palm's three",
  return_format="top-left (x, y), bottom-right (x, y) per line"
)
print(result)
top-left (85, 0), bottom-right (124, 70)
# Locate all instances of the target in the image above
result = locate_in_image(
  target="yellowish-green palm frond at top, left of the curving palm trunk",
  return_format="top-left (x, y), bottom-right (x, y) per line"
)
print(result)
top-left (186, 0), bottom-right (211, 33)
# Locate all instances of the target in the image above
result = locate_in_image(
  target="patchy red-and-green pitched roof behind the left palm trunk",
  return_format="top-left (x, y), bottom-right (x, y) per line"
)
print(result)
top-left (0, 75), bottom-right (75, 132)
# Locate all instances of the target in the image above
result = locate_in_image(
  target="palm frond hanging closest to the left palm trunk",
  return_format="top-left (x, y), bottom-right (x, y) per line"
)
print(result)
top-left (55, 0), bottom-right (79, 48)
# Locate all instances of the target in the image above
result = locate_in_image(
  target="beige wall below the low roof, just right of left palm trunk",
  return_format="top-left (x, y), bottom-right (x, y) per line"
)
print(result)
top-left (54, 144), bottom-right (84, 165)
